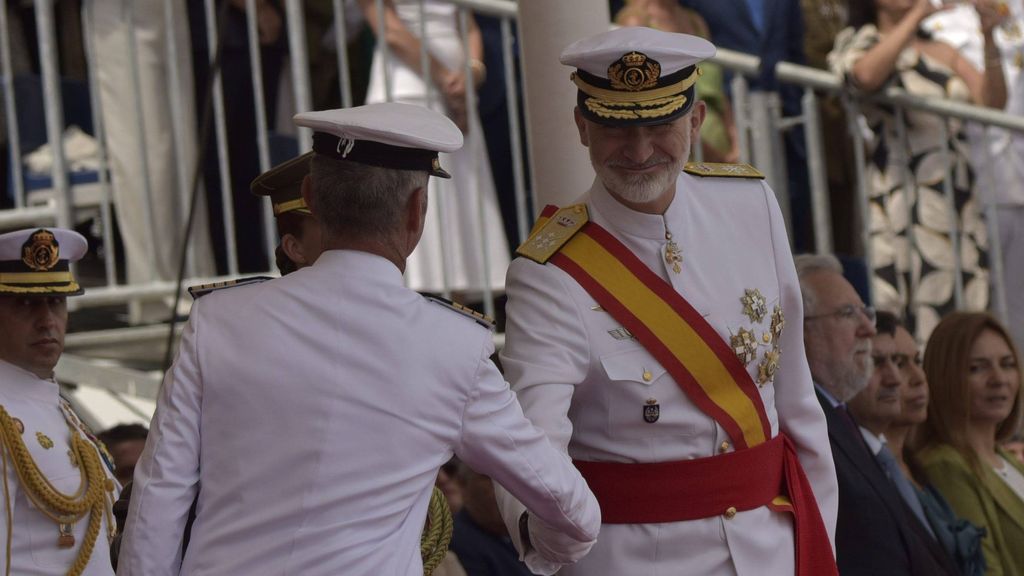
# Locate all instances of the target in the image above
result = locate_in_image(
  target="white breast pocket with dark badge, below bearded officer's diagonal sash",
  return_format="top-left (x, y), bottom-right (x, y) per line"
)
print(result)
top-left (601, 347), bottom-right (697, 439)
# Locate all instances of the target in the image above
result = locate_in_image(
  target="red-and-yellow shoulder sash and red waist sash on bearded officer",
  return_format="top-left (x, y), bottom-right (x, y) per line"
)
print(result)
top-left (524, 206), bottom-right (837, 576)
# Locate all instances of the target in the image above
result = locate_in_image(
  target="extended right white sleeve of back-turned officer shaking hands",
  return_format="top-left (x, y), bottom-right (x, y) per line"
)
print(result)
top-left (456, 325), bottom-right (601, 568)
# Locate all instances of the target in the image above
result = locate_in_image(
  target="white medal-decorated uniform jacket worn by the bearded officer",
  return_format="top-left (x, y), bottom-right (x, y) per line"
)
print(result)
top-left (498, 173), bottom-right (839, 576)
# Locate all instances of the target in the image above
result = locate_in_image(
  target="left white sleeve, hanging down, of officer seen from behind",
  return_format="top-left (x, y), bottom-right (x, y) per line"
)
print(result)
top-left (118, 301), bottom-right (203, 576)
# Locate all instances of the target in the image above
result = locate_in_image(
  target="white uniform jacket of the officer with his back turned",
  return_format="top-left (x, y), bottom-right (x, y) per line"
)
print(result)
top-left (118, 250), bottom-right (600, 576)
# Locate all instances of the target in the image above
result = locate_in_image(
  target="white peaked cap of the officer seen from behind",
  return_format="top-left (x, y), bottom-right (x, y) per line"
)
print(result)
top-left (294, 102), bottom-right (463, 177)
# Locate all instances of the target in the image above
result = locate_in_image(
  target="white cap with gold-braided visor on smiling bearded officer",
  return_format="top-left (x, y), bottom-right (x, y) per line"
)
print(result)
top-left (559, 27), bottom-right (715, 124)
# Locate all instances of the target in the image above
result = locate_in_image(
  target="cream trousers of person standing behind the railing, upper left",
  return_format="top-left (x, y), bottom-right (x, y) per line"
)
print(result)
top-left (83, 0), bottom-right (218, 323)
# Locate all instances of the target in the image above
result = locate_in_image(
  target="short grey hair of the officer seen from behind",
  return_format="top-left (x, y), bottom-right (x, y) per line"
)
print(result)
top-left (310, 155), bottom-right (429, 238)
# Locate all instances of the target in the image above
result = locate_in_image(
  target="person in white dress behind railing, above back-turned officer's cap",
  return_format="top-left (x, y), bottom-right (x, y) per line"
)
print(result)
top-left (359, 0), bottom-right (509, 299)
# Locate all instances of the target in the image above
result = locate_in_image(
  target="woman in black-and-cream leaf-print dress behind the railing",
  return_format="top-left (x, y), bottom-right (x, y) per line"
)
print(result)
top-left (828, 0), bottom-right (1007, 340)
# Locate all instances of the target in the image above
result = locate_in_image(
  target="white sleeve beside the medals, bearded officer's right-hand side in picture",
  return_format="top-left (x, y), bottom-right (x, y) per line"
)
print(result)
top-left (765, 186), bottom-right (839, 552)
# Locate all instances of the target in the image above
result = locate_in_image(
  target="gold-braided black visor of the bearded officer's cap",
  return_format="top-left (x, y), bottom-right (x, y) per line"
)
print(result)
top-left (572, 68), bottom-right (703, 120)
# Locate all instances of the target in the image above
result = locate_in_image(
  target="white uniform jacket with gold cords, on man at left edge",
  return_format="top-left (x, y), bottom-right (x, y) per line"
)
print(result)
top-left (0, 361), bottom-right (117, 576)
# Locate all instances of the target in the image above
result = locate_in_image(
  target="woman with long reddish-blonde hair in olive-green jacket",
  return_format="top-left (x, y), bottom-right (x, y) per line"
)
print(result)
top-left (914, 312), bottom-right (1024, 576)
